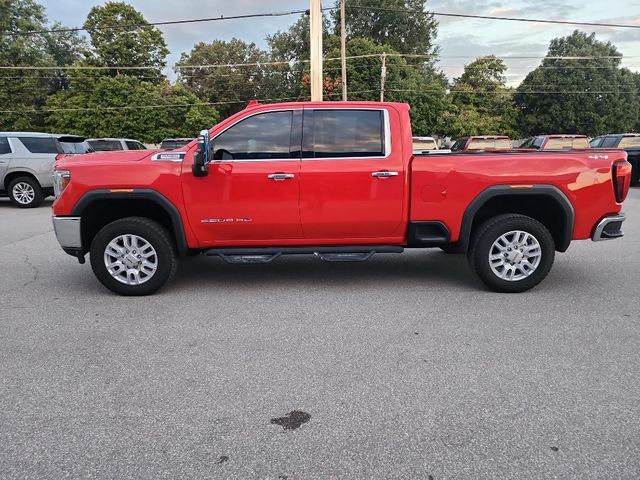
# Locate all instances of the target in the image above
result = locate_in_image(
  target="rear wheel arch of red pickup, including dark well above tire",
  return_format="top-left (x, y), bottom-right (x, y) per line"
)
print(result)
top-left (458, 185), bottom-right (575, 252)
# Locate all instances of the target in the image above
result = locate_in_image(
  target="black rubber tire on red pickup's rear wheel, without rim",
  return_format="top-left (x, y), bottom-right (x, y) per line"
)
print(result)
top-left (467, 214), bottom-right (555, 293)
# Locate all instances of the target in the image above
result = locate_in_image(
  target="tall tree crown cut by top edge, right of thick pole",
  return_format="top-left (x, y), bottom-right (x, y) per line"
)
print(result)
top-left (332, 0), bottom-right (438, 60)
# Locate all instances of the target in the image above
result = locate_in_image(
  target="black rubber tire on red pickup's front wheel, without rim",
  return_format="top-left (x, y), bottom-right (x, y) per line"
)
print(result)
top-left (90, 217), bottom-right (178, 295)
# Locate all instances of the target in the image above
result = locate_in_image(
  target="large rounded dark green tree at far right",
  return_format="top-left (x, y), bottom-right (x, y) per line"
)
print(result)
top-left (514, 30), bottom-right (640, 135)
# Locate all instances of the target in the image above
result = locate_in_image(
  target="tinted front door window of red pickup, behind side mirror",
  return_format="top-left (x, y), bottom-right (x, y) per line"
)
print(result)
top-left (213, 110), bottom-right (293, 160)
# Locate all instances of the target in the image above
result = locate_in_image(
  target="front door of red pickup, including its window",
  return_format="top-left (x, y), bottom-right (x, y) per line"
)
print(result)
top-left (182, 109), bottom-right (302, 246)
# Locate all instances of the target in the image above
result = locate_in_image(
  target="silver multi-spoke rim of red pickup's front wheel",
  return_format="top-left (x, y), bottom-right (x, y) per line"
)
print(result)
top-left (104, 234), bottom-right (158, 285)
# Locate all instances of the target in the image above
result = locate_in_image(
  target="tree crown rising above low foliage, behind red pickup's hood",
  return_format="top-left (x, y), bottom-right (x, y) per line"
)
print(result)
top-left (84, 2), bottom-right (169, 82)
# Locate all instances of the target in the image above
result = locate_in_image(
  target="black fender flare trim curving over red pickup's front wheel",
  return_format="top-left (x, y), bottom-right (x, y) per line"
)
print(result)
top-left (71, 188), bottom-right (189, 256)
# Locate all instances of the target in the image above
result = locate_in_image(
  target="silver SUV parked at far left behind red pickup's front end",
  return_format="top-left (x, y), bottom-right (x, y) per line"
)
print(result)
top-left (0, 132), bottom-right (89, 208)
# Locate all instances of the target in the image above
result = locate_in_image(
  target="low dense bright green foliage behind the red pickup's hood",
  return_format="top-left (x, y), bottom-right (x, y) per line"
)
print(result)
top-left (46, 74), bottom-right (219, 143)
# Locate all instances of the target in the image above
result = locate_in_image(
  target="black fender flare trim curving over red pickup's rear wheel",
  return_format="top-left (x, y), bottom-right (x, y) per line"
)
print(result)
top-left (458, 185), bottom-right (575, 252)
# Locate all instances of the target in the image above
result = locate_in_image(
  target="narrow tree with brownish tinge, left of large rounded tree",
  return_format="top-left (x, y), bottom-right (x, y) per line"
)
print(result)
top-left (447, 55), bottom-right (518, 136)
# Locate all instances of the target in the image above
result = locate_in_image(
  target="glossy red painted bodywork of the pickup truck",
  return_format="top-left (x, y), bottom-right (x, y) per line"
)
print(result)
top-left (53, 102), bottom-right (626, 248)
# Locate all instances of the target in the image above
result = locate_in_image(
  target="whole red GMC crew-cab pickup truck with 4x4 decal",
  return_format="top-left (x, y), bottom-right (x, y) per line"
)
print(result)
top-left (53, 102), bottom-right (631, 295)
